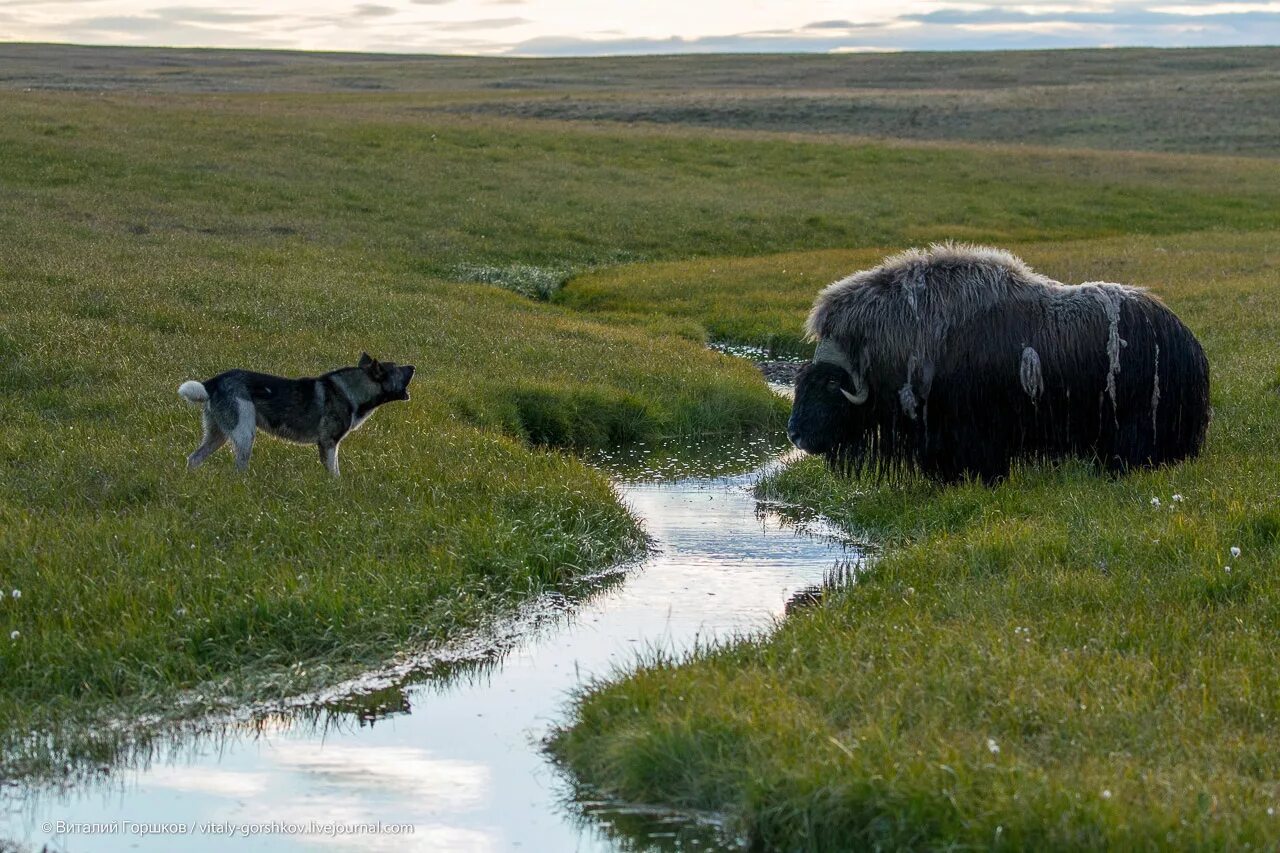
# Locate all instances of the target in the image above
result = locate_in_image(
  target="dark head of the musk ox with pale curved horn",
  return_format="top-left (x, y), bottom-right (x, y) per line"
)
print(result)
top-left (787, 341), bottom-right (872, 457)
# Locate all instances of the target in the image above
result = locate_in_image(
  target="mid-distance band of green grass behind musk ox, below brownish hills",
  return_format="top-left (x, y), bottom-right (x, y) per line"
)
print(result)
top-left (12, 92), bottom-right (1280, 289)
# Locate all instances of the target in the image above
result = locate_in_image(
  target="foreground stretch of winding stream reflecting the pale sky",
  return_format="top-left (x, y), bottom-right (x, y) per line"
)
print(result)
top-left (0, 435), bottom-right (860, 853)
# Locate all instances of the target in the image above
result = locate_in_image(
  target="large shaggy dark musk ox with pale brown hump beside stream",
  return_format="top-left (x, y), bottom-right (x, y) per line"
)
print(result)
top-left (787, 245), bottom-right (1210, 483)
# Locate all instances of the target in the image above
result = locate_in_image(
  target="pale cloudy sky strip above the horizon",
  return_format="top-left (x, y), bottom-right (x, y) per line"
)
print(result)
top-left (0, 0), bottom-right (1280, 56)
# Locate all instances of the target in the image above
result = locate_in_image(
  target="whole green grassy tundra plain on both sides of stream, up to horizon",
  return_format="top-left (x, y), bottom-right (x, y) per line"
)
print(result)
top-left (0, 45), bottom-right (1280, 849)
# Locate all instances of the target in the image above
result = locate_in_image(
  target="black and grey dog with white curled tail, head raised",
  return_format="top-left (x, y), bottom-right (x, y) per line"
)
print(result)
top-left (178, 352), bottom-right (413, 476)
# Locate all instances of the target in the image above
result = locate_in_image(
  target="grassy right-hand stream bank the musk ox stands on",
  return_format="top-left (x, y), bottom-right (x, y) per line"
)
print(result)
top-left (554, 232), bottom-right (1280, 850)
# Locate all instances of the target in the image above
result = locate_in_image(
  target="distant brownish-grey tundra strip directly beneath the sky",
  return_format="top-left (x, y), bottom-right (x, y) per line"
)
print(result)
top-left (0, 45), bottom-right (1280, 156)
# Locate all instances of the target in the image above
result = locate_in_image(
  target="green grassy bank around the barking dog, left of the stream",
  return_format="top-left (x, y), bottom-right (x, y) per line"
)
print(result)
top-left (0, 222), bottom-right (781, 768)
